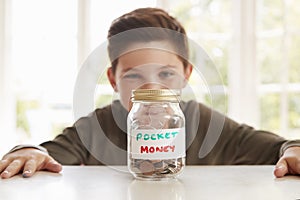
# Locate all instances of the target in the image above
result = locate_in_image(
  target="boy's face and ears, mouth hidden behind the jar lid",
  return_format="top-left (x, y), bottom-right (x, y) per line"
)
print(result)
top-left (107, 43), bottom-right (192, 110)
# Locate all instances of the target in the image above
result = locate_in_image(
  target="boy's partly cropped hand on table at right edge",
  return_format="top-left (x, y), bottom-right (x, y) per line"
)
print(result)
top-left (274, 147), bottom-right (300, 178)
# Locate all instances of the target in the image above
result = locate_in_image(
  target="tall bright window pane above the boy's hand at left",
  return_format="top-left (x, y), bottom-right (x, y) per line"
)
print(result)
top-left (11, 0), bottom-right (77, 148)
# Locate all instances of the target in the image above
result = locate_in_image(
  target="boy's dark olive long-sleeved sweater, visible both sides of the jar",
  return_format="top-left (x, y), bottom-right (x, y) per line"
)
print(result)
top-left (41, 101), bottom-right (300, 165)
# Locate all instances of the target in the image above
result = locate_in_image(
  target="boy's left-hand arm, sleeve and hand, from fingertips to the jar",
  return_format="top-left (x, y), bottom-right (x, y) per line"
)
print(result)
top-left (0, 103), bottom-right (127, 178)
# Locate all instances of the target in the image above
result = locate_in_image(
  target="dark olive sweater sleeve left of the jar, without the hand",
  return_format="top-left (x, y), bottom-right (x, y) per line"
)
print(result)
top-left (41, 102), bottom-right (127, 165)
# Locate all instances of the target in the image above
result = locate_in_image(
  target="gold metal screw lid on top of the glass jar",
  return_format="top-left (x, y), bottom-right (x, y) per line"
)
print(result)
top-left (131, 89), bottom-right (180, 102)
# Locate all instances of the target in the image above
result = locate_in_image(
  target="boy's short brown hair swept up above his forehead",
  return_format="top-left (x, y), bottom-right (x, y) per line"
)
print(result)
top-left (107, 8), bottom-right (189, 73)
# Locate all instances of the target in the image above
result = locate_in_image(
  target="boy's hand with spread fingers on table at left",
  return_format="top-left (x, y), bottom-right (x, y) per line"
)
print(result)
top-left (0, 148), bottom-right (62, 178)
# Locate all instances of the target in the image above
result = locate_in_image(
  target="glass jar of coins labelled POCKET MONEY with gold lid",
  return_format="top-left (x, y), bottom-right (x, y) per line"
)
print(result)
top-left (127, 89), bottom-right (185, 180)
